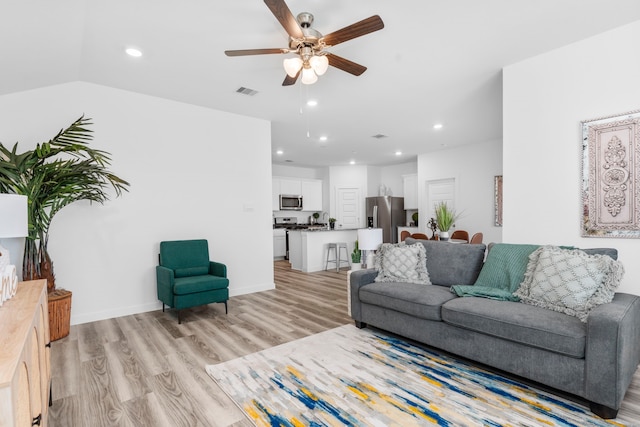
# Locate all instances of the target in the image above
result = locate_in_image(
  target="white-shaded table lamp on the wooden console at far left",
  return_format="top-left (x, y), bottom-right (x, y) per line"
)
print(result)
top-left (0, 194), bottom-right (29, 305)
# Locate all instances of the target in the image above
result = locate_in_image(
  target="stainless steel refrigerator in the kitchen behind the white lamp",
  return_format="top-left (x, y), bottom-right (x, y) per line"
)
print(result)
top-left (367, 196), bottom-right (406, 243)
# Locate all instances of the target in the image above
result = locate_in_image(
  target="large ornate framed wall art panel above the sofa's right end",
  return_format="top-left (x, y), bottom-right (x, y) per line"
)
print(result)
top-left (582, 110), bottom-right (640, 238)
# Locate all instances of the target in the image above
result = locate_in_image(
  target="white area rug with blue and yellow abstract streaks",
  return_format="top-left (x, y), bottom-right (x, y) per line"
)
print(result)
top-left (206, 325), bottom-right (624, 427)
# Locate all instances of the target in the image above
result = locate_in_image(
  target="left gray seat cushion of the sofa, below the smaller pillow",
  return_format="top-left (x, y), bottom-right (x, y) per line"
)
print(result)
top-left (359, 282), bottom-right (457, 321)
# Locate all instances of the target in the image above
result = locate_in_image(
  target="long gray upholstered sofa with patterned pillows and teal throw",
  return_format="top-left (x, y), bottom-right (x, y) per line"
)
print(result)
top-left (350, 238), bottom-right (640, 418)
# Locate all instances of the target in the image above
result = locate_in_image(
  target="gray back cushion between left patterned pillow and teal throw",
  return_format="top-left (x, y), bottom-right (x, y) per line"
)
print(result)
top-left (405, 237), bottom-right (486, 287)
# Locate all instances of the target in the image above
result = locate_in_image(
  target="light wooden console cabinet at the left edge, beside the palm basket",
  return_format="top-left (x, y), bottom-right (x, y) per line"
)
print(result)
top-left (0, 280), bottom-right (51, 427)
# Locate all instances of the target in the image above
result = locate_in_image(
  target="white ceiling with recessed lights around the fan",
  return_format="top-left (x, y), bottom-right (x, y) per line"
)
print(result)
top-left (0, 0), bottom-right (640, 167)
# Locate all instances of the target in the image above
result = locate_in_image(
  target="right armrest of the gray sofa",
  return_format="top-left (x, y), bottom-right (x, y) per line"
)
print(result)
top-left (585, 293), bottom-right (640, 409)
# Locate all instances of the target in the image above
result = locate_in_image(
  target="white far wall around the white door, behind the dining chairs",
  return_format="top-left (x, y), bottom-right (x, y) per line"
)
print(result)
top-left (418, 140), bottom-right (502, 243)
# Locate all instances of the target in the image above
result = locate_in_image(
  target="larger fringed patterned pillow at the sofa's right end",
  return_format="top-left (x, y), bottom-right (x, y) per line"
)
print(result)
top-left (514, 246), bottom-right (624, 322)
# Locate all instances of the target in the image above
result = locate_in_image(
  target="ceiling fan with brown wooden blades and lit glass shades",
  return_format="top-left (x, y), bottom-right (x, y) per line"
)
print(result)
top-left (224, 0), bottom-right (384, 86)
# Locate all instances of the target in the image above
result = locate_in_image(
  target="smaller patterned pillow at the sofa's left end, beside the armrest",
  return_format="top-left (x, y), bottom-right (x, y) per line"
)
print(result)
top-left (374, 242), bottom-right (431, 285)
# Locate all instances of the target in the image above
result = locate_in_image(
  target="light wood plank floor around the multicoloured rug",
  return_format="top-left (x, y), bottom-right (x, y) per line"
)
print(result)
top-left (49, 261), bottom-right (640, 427)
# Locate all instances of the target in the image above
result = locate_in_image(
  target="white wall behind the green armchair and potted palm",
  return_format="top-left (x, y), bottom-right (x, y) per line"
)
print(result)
top-left (0, 82), bottom-right (274, 324)
